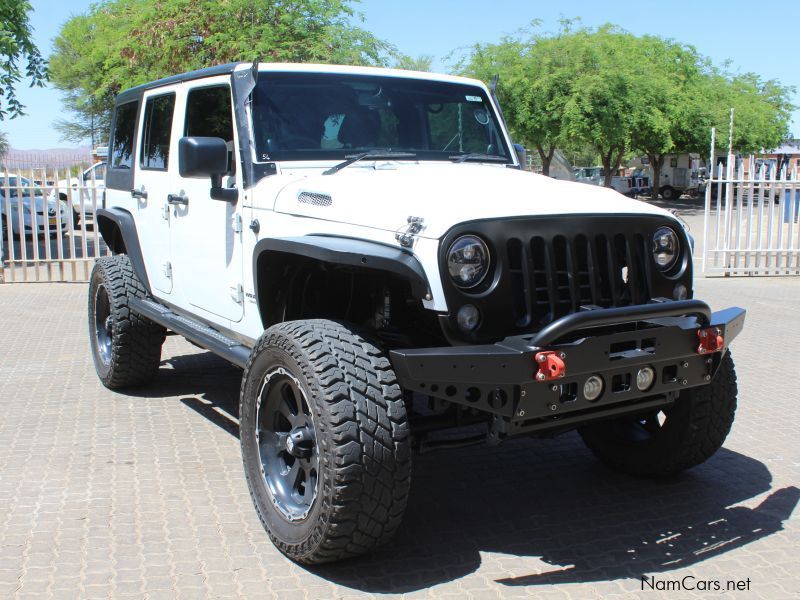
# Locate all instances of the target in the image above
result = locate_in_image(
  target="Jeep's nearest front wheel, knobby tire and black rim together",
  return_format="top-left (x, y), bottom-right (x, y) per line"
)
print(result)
top-left (239, 320), bottom-right (411, 564)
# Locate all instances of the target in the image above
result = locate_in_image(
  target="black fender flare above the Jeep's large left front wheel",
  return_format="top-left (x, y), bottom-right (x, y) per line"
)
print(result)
top-left (253, 235), bottom-right (431, 301)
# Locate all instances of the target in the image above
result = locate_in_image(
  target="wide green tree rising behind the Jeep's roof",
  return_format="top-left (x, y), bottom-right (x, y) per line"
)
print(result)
top-left (50, 0), bottom-right (394, 144)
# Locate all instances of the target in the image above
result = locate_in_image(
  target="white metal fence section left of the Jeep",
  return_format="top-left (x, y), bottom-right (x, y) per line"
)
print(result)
top-left (0, 165), bottom-right (109, 283)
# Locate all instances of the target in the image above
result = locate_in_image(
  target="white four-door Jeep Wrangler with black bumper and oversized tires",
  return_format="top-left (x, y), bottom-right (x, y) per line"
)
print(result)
top-left (89, 64), bottom-right (744, 563)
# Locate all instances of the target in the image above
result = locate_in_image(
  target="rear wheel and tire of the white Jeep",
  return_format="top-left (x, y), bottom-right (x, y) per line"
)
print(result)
top-left (88, 254), bottom-right (166, 389)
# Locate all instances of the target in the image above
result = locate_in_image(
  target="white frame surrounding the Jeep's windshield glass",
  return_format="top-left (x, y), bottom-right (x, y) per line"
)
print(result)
top-left (247, 70), bottom-right (519, 167)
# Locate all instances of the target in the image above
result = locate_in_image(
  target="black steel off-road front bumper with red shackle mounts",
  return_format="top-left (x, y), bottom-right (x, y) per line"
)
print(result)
top-left (390, 300), bottom-right (745, 439)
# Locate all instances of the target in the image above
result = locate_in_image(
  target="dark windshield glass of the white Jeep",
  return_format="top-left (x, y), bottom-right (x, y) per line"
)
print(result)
top-left (253, 72), bottom-right (511, 163)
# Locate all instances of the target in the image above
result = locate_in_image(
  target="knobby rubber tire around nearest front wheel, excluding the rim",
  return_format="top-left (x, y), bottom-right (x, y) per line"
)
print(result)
top-left (240, 320), bottom-right (411, 564)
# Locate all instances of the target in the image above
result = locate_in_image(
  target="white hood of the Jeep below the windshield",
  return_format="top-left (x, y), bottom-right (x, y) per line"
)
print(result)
top-left (275, 163), bottom-right (673, 239)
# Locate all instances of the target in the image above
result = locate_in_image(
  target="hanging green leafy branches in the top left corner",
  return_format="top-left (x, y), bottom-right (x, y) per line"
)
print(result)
top-left (0, 0), bottom-right (47, 120)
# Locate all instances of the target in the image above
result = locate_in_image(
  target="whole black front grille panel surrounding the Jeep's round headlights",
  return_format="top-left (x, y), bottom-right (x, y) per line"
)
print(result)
top-left (440, 214), bottom-right (692, 343)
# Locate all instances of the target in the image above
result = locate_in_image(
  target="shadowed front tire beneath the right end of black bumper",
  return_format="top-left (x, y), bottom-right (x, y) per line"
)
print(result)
top-left (580, 352), bottom-right (737, 477)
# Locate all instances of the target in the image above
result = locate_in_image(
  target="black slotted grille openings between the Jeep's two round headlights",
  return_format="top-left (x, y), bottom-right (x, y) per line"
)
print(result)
top-left (506, 233), bottom-right (651, 327)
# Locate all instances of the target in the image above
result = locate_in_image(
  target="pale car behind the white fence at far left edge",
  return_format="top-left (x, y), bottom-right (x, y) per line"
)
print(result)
top-left (0, 174), bottom-right (69, 235)
